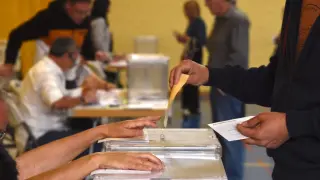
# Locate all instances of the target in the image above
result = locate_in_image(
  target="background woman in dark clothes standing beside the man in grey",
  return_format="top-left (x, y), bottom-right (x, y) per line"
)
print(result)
top-left (175, 0), bottom-right (206, 128)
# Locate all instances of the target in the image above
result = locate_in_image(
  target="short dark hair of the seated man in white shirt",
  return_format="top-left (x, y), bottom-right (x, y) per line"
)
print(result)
top-left (49, 37), bottom-right (77, 57)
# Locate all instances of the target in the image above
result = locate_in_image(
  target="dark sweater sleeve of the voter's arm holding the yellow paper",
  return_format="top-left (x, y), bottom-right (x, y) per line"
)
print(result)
top-left (207, 47), bottom-right (278, 107)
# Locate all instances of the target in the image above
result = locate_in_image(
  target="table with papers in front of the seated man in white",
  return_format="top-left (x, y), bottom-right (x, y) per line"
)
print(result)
top-left (68, 90), bottom-right (168, 153)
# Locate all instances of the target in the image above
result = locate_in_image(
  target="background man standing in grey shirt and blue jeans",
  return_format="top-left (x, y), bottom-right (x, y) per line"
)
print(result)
top-left (206, 0), bottom-right (250, 180)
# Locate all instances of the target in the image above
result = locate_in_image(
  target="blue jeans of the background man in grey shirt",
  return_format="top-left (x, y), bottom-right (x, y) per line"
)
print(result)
top-left (210, 87), bottom-right (245, 180)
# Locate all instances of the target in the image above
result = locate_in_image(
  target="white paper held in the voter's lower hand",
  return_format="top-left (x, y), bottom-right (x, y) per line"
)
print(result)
top-left (208, 116), bottom-right (254, 141)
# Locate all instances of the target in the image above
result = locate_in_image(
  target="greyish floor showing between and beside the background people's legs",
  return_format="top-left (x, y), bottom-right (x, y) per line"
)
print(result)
top-left (171, 99), bottom-right (273, 180)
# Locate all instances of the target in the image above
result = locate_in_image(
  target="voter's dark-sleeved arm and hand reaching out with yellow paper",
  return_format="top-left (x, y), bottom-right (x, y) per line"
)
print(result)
top-left (170, 47), bottom-right (278, 106)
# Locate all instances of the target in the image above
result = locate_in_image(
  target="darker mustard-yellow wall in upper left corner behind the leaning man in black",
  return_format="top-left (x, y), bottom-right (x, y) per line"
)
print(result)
top-left (0, 0), bottom-right (50, 74)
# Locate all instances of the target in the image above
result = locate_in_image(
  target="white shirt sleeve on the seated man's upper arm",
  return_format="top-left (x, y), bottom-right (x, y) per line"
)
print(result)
top-left (38, 74), bottom-right (65, 107)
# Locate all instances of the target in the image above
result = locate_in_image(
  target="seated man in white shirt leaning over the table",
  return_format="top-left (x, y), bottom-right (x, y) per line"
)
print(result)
top-left (20, 37), bottom-right (109, 148)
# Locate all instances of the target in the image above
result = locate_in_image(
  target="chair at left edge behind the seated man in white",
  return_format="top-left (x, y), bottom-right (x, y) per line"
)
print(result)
top-left (0, 90), bottom-right (36, 155)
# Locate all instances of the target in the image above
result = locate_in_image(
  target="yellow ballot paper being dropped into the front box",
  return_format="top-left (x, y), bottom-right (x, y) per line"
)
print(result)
top-left (163, 74), bottom-right (189, 128)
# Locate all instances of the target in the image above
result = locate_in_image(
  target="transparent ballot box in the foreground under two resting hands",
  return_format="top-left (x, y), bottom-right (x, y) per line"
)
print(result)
top-left (91, 129), bottom-right (227, 180)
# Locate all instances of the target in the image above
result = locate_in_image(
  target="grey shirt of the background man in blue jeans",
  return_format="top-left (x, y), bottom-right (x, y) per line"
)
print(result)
top-left (207, 7), bottom-right (250, 68)
